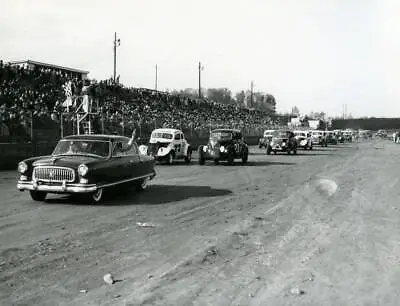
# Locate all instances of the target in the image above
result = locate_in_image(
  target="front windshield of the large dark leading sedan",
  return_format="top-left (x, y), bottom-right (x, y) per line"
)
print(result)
top-left (53, 139), bottom-right (110, 157)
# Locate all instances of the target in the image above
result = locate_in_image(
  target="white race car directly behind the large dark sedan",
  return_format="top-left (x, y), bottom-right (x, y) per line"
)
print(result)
top-left (140, 129), bottom-right (192, 165)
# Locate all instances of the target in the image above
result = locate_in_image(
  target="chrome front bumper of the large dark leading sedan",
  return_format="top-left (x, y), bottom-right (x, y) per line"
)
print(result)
top-left (17, 180), bottom-right (97, 193)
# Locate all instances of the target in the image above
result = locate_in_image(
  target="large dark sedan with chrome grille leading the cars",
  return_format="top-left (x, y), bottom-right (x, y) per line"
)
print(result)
top-left (17, 135), bottom-right (156, 203)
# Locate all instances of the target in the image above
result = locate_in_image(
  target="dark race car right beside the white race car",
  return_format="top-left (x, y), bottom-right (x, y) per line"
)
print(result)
top-left (199, 129), bottom-right (249, 165)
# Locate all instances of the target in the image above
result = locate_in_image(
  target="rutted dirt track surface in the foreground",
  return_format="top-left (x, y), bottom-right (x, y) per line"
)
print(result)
top-left (0, 141), bottom-right (400, 306)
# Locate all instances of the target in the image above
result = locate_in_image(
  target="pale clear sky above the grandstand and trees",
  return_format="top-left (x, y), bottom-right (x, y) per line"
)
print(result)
top-left (0, 0), bottom-right (400, 117)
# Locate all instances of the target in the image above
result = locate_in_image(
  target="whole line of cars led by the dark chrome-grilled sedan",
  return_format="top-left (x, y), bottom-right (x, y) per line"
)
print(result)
top-left (17, 125), bottom-right (360, 203)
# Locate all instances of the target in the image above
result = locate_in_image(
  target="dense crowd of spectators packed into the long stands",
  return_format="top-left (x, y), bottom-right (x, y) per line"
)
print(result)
top-left (0, 58), bottom-right (282, 141)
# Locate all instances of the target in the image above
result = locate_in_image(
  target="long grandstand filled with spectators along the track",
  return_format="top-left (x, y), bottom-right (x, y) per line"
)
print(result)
top-left (0, 61), bottom-right (276, 143)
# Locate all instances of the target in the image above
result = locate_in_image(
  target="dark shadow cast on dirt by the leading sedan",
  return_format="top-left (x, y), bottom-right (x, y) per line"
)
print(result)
top-left (45, 185), bottom-right (232, 206)
